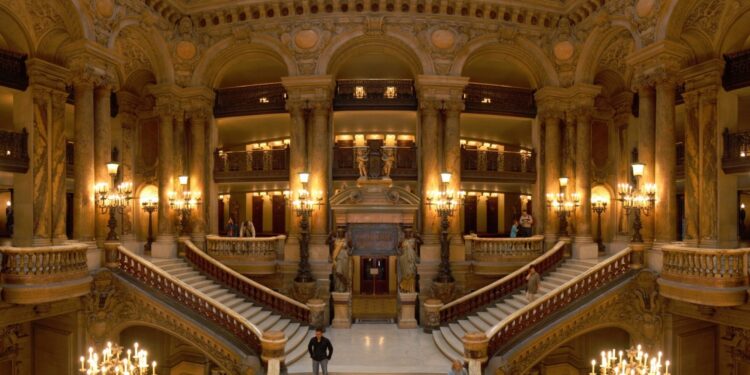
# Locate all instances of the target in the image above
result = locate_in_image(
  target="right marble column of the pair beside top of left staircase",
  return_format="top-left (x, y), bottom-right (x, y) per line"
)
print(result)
top-left (190, 104), bottom-right (210, 248)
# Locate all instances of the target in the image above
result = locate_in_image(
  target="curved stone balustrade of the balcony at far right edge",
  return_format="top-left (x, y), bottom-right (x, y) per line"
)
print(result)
top-left (661, 245), bottom-right (750, 288)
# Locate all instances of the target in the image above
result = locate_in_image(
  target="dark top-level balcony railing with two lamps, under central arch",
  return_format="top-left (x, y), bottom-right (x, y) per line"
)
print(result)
top-left (333, 79), bottom-right (417, 111)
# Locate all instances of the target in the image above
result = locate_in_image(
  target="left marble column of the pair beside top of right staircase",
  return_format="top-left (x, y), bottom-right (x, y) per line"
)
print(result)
top-left (540, 113), bottom-right (561, 244)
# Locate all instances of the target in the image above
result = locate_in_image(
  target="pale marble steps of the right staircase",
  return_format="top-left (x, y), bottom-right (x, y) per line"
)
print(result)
top-left (432, 259), bottom-right (598, 359)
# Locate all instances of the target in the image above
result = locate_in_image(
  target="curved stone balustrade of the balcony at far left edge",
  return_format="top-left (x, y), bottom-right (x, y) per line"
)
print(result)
top-left (0, 244), bottom-right (88, 284)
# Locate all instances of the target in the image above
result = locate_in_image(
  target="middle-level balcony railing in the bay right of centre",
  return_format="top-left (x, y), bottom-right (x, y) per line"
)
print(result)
top-left (461, 146), bottom-right (536, 183)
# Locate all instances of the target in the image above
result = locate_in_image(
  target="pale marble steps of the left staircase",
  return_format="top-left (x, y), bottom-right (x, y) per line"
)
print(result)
top-left (148, 258), bottom-right (314, 365)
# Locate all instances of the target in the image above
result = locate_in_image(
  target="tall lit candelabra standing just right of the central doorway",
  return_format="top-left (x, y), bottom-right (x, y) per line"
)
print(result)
top-left (427, 172), bottom-right (466, 283)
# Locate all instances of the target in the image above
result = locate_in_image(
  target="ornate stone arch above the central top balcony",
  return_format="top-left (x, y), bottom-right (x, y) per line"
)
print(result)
top-left (315, 30), bottom-right (435, 77)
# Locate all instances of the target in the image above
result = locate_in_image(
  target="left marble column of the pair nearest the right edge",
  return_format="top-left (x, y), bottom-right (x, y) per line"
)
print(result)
top-left (682, 90), bottom-right (701, 246)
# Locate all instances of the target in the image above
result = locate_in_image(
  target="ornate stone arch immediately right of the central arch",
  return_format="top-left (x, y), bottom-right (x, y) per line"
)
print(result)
top-left (451, 34), bottom-right (560, 88)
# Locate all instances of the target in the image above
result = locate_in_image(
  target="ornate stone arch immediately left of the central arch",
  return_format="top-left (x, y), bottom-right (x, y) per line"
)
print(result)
top-left (192, 35), bottom-right (297, 87)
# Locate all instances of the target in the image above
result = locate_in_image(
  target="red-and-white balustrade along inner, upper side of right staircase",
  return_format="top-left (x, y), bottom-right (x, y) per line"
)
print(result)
top-left (440, 241), bottom-right (566, 323)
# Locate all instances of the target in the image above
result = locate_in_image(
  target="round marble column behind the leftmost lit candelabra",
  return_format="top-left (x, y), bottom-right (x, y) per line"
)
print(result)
top-left (94, 82), bottom-right (114, 244)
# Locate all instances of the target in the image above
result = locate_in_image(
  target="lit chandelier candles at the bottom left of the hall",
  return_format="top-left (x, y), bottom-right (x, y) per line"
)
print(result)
top-left (78, 342), bottom-right (156, 375)
